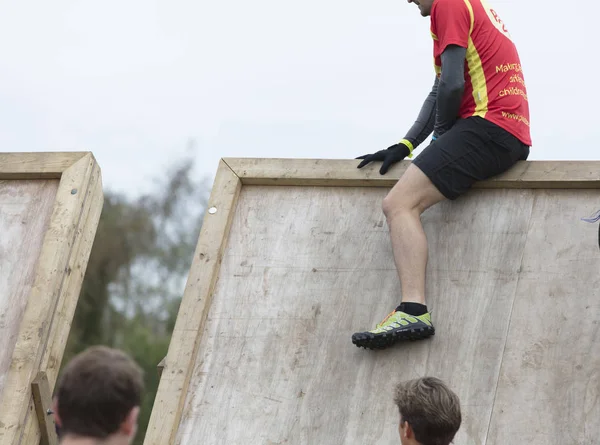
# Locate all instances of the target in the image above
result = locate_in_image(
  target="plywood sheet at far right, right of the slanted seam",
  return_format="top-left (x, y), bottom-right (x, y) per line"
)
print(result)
top-left (487, 190), bottom-right (600, 445)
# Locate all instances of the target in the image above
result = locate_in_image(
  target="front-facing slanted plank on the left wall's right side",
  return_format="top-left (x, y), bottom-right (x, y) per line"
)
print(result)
top-left (0, 154), bottom-right (95, 444)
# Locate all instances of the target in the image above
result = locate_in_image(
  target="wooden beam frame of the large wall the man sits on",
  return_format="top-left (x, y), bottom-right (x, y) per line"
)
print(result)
top-left (144, 158), bottom-right (600, 445)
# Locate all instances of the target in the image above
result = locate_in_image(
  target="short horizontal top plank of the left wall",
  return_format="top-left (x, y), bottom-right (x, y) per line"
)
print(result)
top-left (0, 152), bottom-right (91, 180)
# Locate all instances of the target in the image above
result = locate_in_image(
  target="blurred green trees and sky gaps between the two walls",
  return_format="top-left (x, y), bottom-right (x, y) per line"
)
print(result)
top-left (63, 152), bottom-right (209, 444)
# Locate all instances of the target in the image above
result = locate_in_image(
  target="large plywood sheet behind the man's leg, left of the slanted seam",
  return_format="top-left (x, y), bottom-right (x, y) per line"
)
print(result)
top-left (177, 186), bottom-right (540, 445)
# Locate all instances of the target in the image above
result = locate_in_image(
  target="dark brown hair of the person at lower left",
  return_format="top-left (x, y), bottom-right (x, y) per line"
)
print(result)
top-left (55, 346), bottom-right (144, 439)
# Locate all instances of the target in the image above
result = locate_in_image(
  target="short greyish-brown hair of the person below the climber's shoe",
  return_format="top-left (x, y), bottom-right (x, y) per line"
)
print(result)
top-left (394, 377), bottom-right (462, 445)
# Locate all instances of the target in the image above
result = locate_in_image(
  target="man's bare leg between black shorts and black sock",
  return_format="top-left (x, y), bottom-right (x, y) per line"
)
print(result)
top-left (383, 164), bottom-right (445, 304)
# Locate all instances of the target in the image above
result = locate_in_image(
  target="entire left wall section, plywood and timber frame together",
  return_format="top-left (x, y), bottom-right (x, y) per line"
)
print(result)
top-left (0, 153), bottom-right (103, 445)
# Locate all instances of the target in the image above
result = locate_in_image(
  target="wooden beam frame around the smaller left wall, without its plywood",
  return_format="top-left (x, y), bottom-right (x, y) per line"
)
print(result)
top-left (0, 152), bottom-right (104, 445)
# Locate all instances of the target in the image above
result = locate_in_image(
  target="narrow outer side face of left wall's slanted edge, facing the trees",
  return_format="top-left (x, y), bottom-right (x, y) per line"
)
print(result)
top-left (23, 159), bottom-right (104, 444)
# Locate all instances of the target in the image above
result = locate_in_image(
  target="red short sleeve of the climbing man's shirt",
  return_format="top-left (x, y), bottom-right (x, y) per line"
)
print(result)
top-left (431, 0), bottom-right (471, 57)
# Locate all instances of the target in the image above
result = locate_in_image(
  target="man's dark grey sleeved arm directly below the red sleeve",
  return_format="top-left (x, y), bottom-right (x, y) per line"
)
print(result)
top-left (433, 45), bottom-right (467, 137)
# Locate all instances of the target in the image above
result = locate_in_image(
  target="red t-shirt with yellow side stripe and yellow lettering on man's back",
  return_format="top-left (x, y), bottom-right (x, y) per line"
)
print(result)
top-left (431, 0), bottom-right (531, 145)
